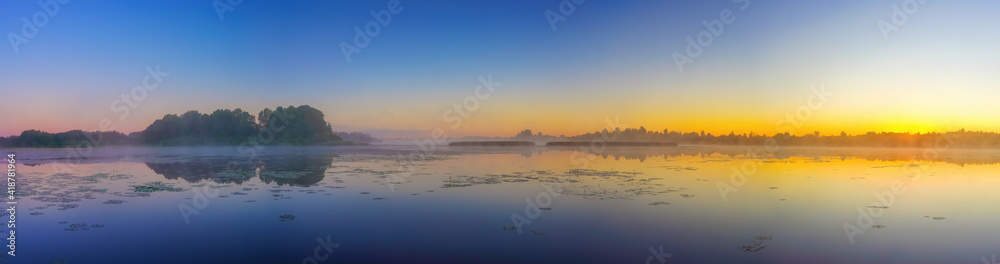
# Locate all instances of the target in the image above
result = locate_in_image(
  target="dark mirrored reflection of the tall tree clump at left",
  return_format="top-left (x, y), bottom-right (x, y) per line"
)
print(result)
top-left (146, 155), bottom-right (333, 186)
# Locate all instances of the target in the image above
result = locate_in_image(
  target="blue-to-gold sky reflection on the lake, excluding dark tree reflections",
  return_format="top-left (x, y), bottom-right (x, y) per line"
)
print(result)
top-left (18, 148), bottom-right (1000, 263)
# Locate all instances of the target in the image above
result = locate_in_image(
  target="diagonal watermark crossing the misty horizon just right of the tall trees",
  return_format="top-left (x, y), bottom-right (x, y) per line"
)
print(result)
top-left (385, 73), bottom-right (503, 192)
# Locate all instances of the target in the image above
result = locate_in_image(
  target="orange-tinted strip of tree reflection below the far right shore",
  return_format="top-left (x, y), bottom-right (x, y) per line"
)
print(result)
top-left (549, 146), bottom-right (1000, 166)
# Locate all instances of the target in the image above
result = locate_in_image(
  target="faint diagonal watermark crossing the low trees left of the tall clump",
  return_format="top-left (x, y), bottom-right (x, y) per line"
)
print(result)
top-left (52, 64), bottom-right (170, 173)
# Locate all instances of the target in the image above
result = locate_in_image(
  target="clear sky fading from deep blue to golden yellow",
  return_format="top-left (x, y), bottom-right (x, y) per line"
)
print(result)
top-left (0, 0), bottom-right (1000, 138)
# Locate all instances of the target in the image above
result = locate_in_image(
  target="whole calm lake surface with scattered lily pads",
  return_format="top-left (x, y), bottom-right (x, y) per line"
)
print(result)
top-left (0, 146), bottom-right (1000, 264)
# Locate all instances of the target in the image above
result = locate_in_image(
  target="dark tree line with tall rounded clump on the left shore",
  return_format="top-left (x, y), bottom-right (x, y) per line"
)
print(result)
top-left (0, 105), bottom-right (375, 147)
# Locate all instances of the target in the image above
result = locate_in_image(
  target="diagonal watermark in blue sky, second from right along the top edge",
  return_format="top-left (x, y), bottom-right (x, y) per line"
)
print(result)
top-left (672, 0), bottom-right (750, 73)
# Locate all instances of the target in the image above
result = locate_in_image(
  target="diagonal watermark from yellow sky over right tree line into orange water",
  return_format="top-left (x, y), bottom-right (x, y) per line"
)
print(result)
top-left (715, 84), bottom-right (833, 202)
